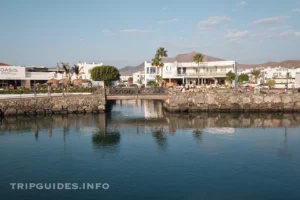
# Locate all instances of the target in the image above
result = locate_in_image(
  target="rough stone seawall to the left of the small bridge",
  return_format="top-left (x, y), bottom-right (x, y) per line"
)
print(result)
top-left (0, 94), bottom-right (106, 116)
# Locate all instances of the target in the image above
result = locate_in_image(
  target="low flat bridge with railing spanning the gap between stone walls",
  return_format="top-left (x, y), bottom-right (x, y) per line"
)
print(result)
top-left (106, 87), bottom-right (168, 100)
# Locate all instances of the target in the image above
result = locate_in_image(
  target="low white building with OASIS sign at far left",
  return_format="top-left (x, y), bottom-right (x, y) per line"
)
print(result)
top-left (0, 66), bottom-right (63, 88)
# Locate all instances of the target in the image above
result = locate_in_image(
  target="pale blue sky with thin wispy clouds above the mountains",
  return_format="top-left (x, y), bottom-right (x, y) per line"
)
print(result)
top-left (0, 0), bottom-right (300, 67)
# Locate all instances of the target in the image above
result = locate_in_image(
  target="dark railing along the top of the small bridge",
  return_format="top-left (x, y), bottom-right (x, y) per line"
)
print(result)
top-left (106, 87), bottom-right (167, 96)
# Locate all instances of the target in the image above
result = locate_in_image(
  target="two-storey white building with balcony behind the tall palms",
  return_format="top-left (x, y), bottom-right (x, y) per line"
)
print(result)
top-left (145, 61), bottom-right (237, 87)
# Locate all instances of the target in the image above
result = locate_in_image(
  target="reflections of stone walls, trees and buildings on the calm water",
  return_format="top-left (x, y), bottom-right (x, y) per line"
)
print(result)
top-left (0, 100), bottom-right (300, 156)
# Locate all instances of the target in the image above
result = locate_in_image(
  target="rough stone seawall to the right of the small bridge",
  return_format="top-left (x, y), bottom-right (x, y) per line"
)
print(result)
top-left (163, 90), bottom-right (300, 112)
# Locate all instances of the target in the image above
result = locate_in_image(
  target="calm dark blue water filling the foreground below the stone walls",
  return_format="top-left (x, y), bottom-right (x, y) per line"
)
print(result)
top-left (0, 101), bottom-right (300, 200)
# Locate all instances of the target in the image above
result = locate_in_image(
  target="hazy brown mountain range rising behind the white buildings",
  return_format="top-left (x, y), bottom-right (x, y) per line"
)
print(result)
top-left (119, 52), bottom-right (300, 76)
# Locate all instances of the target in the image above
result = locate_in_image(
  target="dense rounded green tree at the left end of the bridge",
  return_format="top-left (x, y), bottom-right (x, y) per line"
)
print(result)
top-left (91, 65), bottom-right (120, 86)
